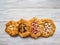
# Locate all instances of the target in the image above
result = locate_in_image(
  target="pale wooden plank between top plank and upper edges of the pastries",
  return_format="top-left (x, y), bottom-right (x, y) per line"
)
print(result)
top-left (0, 8), bottom-right (60, 21)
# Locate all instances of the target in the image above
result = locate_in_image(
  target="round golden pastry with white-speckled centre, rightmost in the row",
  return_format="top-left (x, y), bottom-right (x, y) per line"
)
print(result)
top-left (41, 19), bottom-right (56, 37)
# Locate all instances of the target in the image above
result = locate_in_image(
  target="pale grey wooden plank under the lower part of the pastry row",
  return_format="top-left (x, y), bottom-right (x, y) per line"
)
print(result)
top-left (0, 21), bottom-right (60, 45)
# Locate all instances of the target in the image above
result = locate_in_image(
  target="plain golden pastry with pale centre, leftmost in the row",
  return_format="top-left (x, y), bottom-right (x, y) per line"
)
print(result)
top-left (5, 20), bottom-right (18, 36)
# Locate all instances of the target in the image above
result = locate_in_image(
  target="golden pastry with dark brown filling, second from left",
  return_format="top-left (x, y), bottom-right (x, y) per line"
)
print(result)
top-left (18, 19), bottom-right (30, 37)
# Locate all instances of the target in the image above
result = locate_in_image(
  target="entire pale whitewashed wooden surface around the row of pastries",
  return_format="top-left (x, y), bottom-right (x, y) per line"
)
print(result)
top-left (0, 0), bottom-right (60, 45)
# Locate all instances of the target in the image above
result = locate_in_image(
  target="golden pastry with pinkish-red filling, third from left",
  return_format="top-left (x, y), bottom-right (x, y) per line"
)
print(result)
top-left (29, 17), bottom-right (42, 39)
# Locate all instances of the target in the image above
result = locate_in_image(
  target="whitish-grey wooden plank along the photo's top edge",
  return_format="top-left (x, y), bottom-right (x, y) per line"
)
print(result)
top-left (0, 0), bottom-right (60, 10)
